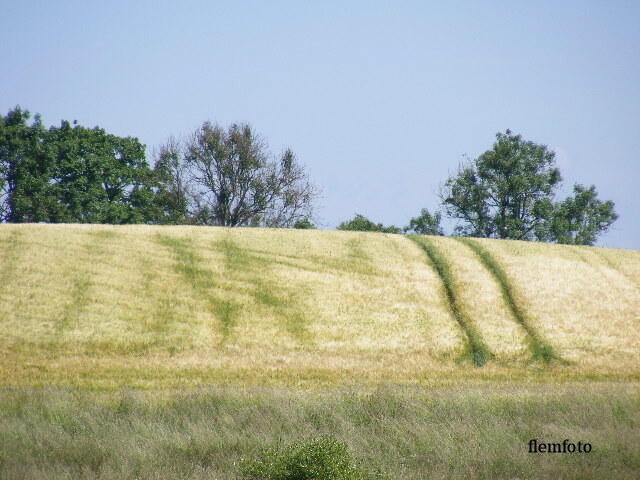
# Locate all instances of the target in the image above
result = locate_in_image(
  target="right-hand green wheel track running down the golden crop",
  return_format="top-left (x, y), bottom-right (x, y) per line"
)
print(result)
top-left (456, 237), bottom-right (560, 362)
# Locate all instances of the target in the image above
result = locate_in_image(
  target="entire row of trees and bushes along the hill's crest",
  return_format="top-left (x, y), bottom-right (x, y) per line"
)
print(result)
top-left (0, 107), bottom-right (618, 245)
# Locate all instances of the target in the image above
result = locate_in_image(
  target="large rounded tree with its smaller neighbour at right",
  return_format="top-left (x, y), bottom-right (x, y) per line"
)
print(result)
top-left (440, 130), bottom-right (617, 244)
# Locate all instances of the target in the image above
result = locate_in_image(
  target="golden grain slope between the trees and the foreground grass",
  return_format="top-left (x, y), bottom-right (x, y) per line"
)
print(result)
top-left (0, 225), bottom-right (640, 387)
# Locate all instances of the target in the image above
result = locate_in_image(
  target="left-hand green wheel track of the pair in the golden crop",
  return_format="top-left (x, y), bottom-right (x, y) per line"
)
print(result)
top-left (409, 235), bottom-right (494, 367)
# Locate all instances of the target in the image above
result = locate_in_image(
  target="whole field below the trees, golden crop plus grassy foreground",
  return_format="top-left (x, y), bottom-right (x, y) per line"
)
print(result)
top-left (0, 225), bottom-right (640, 479)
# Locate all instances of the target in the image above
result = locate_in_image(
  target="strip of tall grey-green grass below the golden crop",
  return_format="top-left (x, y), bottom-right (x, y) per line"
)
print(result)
top-left (0, 383), bottom-right (640, 480)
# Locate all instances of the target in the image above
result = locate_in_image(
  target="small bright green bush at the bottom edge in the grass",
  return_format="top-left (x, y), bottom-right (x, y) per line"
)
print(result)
top-left (240, 436), bottom-right (380, 480)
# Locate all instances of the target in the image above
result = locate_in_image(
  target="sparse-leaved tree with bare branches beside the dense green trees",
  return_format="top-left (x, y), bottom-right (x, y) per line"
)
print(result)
top-left (156, 122), bottom-right (317, 227)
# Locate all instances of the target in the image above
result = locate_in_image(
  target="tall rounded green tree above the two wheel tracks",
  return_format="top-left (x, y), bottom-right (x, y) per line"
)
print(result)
top-left (441, 130), bottom-right (562, 240)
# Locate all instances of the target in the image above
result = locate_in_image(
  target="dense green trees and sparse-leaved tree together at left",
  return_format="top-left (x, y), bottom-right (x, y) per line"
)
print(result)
top-left (0, 107), bottom-right (317, 227)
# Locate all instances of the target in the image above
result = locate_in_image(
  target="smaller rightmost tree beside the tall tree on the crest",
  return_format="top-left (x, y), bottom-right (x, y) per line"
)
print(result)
top-left (549, 184), bottom-right (618, 245)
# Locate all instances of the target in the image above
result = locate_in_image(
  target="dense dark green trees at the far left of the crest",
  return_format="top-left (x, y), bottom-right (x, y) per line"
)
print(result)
top-left (0, 107), bottom-right (157, 223)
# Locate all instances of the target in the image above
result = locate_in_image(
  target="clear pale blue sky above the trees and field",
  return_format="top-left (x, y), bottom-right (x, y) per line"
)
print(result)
top-left (0, 0), bottom-right (640, 250)
